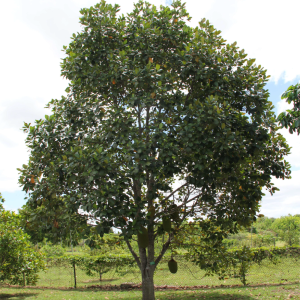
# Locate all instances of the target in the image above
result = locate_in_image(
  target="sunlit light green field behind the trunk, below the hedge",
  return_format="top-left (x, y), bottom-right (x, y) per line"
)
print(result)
top-left (31, 258), bottom-right (300, 287)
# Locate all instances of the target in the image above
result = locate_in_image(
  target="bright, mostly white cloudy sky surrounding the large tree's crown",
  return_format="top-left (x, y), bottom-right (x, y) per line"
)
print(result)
top-left (0, 0), bottom-right (300, 217)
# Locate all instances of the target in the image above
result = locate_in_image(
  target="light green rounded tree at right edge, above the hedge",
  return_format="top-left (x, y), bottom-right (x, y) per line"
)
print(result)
top-left (271, 215), bottom-right (300, 246)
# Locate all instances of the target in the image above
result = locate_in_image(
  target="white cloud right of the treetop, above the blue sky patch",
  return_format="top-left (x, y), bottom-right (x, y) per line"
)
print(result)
top-left (186, 0), bottom-right (300, 82)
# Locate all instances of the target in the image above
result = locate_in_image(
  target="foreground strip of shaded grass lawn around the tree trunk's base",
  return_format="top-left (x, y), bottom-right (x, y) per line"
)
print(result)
top-left (0, 284), bottom-right (300, 300)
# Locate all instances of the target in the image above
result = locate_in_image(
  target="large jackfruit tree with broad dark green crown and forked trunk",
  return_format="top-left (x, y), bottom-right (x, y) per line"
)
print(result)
top-left (20, 1), bottom-right (290, 300)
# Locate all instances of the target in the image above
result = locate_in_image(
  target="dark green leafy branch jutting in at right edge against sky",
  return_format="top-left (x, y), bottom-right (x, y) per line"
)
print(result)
top-left (278, 83), bottom-right (300, 134)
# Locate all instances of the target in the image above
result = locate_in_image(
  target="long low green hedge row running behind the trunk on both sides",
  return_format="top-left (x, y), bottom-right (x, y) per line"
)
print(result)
top-left (42, 246), bottom-right (300, 287)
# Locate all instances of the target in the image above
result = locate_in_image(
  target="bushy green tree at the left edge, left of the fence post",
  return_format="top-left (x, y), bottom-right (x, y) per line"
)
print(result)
top-left (0, 193), bottom-right (45, 285)
